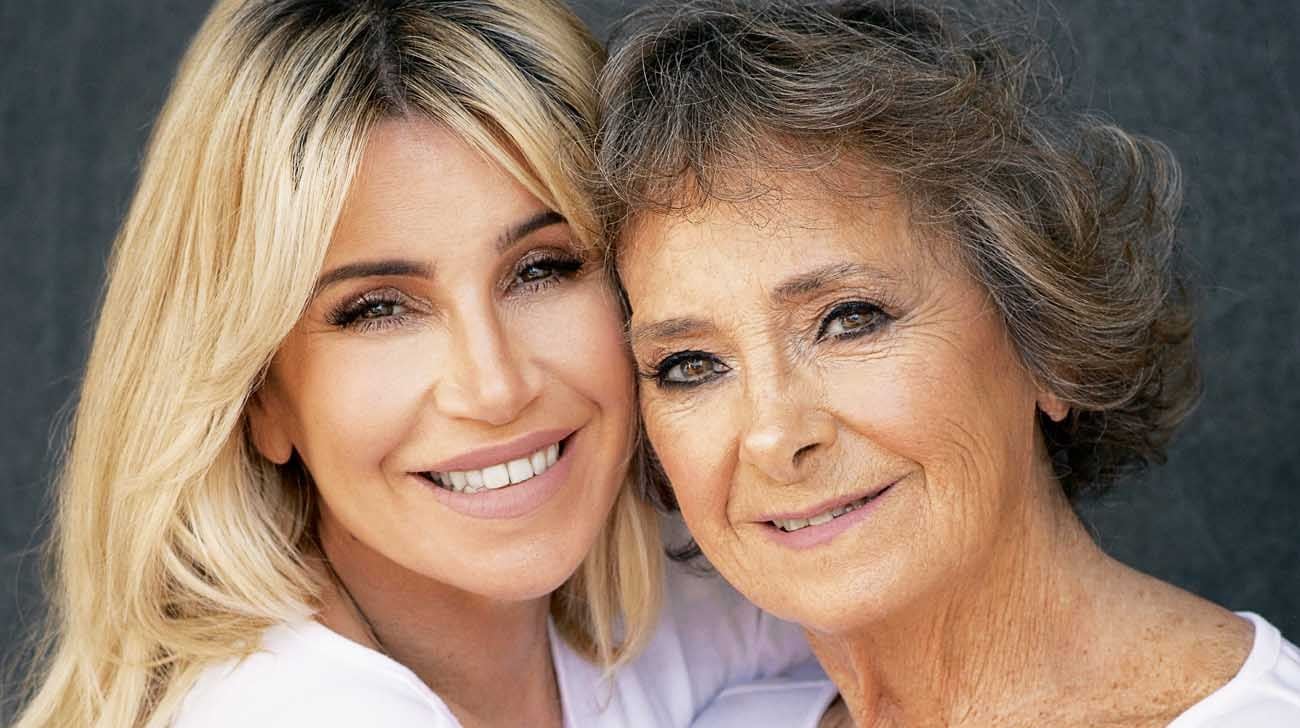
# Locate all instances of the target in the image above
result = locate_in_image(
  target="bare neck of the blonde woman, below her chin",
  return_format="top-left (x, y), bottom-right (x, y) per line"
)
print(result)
top-left (319, 519), bottom-right (563, 728)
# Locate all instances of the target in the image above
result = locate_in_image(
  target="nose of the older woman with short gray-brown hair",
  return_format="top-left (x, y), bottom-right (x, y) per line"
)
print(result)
top-left (740, 369), bottom-right (836, 485)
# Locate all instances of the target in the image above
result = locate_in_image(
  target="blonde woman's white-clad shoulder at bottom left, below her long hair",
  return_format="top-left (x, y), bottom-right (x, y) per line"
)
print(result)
top-left (173, 621), bottom-right (459, 728)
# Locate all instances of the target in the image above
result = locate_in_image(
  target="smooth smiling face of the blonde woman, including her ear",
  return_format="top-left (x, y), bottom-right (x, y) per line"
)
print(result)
top-left (251, 121), bottom-right (634, 599)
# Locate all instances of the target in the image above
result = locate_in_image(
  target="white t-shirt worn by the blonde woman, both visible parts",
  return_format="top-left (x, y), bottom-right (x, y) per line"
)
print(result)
top-left (173, 563), bottom-right (836, 728)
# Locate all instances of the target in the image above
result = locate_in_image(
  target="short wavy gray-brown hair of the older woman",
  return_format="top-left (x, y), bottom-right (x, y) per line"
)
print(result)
top-left (597, 0), bottom-right (1200, 502)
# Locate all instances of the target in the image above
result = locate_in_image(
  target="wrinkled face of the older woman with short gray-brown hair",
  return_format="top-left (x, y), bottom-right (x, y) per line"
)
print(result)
top-left (619, 184), bottom-right (1045, 633)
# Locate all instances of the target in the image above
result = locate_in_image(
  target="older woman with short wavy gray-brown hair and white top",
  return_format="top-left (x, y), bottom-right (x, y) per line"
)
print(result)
top-left (598, 1), bottom-right (1300, 728)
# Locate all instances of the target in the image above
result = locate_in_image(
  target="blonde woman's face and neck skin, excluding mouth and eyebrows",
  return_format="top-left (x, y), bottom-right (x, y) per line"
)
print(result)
top-left (250, 121), bottom-right (634, 725)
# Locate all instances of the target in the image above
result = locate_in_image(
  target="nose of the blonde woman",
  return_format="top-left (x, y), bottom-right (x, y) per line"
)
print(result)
top-left (434, 308), bottom-right (541, 425)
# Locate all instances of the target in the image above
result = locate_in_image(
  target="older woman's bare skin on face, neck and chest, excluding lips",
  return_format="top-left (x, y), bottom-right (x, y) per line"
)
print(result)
top-left (618, 184), bottom-right (1251, 728)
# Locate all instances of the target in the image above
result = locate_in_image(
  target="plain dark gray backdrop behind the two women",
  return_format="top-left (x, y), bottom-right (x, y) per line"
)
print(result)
top-left (0, 0), bottom-right (1300, 723)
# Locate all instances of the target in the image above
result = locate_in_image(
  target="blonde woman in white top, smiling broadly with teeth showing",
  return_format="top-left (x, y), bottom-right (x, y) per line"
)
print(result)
top-left (17, 0), bottom-right (833, 728)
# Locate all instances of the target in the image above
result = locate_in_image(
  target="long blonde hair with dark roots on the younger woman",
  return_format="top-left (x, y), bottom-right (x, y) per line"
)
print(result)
top-left (16, 0), bottom-right (660, 728)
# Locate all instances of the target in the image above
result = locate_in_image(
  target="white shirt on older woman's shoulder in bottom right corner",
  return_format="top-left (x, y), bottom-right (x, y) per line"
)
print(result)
top-left (1169, 612), bottom-right (1300, 728)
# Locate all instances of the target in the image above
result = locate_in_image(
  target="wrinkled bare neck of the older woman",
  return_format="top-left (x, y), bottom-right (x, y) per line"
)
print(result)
top-left (809, 478), bottom-right (1132, 728)
